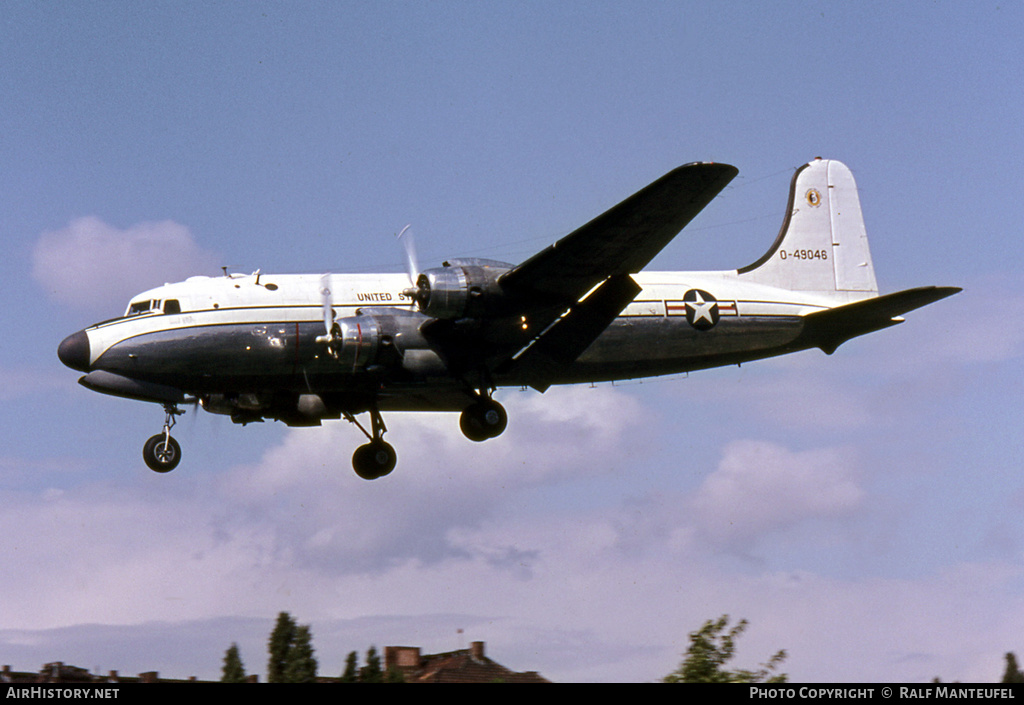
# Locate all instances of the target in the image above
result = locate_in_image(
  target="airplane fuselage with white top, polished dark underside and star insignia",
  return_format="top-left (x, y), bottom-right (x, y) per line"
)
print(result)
top-left (64, 272), bottom-right (865, 410)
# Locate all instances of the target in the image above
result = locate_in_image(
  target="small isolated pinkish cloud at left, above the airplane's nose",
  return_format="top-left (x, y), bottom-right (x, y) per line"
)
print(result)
top-left (32, 216), bottom-right (217, 314)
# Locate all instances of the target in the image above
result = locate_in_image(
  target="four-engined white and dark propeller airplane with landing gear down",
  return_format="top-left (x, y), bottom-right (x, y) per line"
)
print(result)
top-left (57, 158), bottom-right (961, 480)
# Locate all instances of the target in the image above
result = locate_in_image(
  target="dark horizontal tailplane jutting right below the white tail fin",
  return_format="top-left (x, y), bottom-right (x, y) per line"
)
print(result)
top-left (797, 286), bottom-right (961, 355)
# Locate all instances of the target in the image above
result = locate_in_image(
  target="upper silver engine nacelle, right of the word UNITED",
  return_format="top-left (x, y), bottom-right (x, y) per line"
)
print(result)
top-left (412, 259), bottom-right (512, 319)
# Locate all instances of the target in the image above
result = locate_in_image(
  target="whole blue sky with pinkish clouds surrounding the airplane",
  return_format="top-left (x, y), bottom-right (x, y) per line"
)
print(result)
top-left (0, 1), bottom-right (1024, 681)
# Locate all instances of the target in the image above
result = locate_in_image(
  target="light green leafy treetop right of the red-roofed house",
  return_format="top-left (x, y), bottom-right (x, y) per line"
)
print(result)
top-left (663, 615), bottom-right (787, 682)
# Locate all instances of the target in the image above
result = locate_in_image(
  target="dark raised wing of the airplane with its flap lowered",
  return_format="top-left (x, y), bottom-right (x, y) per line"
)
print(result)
top-left (424, 164), bottom-right (738, 388)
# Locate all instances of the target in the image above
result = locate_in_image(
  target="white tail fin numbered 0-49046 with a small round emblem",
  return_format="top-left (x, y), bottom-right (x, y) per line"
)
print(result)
top-left (737, 159), bottom-right (879, 294)
